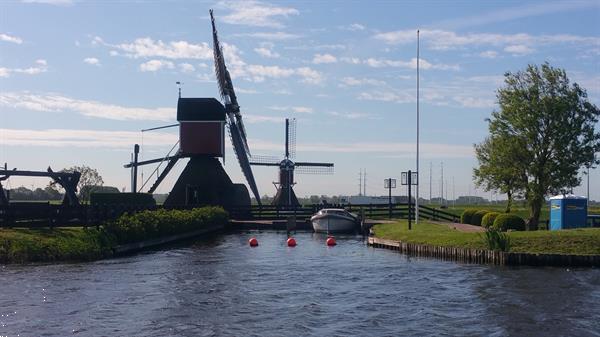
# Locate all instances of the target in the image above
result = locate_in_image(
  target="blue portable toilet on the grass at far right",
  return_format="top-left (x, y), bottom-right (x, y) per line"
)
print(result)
top-left (550, 194), bottom-right (588, 230)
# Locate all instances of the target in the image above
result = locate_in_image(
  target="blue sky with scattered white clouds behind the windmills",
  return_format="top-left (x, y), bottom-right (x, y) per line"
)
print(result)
top-left (0, 0), bottom-right (600, 200)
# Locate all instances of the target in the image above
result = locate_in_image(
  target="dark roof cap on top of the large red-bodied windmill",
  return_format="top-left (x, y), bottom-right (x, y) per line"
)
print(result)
top-left (177, 98), bottom-right (225, 122)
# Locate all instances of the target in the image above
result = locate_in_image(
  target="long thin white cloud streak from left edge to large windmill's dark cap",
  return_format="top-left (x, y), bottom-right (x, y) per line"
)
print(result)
top-left (0, 91), bottom-right (175, 121)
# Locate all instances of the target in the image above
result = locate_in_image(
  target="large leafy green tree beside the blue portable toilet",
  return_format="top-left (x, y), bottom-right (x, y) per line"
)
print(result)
top-left (474, 63), bottom-right (600, 230)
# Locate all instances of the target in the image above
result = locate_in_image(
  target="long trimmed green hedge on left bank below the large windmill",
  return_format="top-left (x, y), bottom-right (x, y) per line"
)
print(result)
top-left (104, 207), bottom-right (229, 244)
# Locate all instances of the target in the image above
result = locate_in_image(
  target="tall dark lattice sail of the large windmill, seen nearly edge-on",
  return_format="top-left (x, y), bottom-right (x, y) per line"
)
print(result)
top-left (210, 9), bottom-right (261, 205)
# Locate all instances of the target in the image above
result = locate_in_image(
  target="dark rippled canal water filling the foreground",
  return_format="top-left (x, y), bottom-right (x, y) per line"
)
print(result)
top-left (0, 232), bottom-right (600, 336)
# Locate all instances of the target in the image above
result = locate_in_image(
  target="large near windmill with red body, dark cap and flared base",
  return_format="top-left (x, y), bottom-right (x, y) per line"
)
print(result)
top-left (125, 10), bottom-right (260, 207)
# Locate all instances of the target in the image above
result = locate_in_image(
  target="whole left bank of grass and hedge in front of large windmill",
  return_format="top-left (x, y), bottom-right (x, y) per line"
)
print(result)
top-left (0, 207), bottom-right (228, 263)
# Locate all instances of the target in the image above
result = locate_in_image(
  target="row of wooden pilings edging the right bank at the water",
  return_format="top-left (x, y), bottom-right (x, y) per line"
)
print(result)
top-left (368, 237), bottom-right (600, 267)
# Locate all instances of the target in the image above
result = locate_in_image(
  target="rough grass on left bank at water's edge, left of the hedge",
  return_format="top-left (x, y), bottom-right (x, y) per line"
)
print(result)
top-left (0, 228), bottom-right (113, 263)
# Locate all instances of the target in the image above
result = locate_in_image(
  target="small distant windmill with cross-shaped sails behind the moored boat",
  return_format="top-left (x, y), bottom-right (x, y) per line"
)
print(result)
top-left (250, 118), bottom-right (333, 206)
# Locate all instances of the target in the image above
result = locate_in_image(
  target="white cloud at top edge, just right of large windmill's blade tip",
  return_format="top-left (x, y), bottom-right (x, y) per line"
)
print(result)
top-left (217, 0), bottom-right (300, 28)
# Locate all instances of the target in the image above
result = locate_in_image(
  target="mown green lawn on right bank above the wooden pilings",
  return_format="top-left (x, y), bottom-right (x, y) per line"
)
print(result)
top-left (373, 221), bottom-right (600, 255)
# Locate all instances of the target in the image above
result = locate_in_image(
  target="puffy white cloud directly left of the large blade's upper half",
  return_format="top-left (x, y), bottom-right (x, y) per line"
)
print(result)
top-left (102, 36), bottom-right (213, 60)
